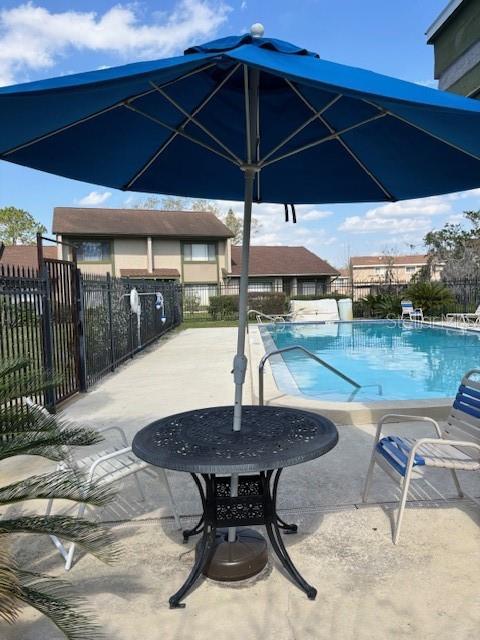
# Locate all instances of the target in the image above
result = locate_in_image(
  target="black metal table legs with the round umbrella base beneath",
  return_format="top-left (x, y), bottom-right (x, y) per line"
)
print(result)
top-left (169, 469), bottom-right (317, 609)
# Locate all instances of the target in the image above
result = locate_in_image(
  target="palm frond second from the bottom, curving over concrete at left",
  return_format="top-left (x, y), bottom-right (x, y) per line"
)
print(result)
top-left (0, 516), bottom-right (120, 563)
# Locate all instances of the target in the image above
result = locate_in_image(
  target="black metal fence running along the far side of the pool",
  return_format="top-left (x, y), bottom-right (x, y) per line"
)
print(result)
top-left (182, 280), bottom-right (480, 322)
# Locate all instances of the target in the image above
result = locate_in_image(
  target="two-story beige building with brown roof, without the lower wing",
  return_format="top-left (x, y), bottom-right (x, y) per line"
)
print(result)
top-left (52, 207), bottom-right (232, 285)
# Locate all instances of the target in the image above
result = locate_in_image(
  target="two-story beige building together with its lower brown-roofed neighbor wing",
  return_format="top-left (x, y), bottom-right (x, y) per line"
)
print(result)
top-left (52, 207), bottom-right (338, 305)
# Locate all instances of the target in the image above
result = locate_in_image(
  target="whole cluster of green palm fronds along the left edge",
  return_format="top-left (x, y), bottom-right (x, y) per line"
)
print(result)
top-left (0, 360), bottom-right (118, 640)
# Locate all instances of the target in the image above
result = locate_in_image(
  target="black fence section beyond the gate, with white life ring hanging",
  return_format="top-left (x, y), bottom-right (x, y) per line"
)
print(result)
top-left (81, 275), bottom-right (182, 387)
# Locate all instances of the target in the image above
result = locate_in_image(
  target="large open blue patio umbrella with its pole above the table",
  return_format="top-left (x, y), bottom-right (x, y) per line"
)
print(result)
top-left (0, 25), bottom-right (480, 438)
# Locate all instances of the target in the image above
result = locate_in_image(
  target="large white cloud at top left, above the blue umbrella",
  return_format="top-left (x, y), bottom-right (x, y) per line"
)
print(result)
top-left (0, 0), bottom-right (230, 84)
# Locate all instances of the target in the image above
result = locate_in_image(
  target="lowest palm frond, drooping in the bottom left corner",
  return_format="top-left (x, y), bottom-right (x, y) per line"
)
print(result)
top-left (18, 571), bottom-right (104, 640)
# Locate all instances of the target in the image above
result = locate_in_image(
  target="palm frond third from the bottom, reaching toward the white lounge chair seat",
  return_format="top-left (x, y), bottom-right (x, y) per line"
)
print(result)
top-left (0, 469), bottom-right (114, 507)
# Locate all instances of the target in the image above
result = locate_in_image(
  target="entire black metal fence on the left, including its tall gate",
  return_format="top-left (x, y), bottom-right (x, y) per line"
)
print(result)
top-left (0, 260), bottom-right (182, 408)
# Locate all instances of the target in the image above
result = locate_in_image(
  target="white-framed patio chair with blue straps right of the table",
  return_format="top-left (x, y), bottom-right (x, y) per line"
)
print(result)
top-left (362, 369), bottom-right (480, 544)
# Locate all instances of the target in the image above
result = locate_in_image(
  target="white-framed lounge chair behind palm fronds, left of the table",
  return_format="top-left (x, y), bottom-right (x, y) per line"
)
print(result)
top-left (24, 398), bottom-right (182, 571)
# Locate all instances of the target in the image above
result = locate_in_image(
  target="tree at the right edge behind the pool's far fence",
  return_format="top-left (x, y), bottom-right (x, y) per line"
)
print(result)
top-left (422, 211), bottom-right (480, 280)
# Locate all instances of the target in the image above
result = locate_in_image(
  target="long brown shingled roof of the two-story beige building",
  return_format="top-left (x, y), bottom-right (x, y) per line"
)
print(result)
top-left (52, 207), bottom-right (233, 238)
